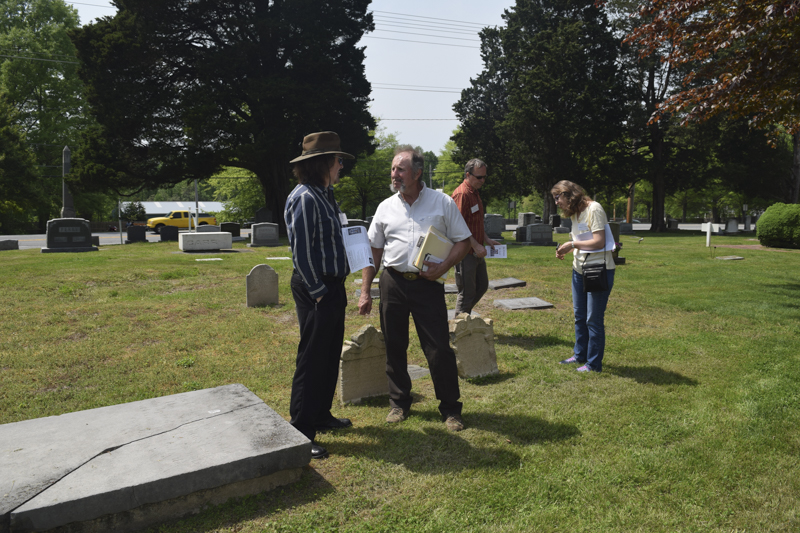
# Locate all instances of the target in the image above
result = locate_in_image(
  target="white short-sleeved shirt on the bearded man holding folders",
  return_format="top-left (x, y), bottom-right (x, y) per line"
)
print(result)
top-left (367, 182), bottom-right (472, 272)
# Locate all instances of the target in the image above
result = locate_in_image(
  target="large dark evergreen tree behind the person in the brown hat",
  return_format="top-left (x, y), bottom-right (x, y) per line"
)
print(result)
top-left (73, 0), bottom-right (375, 224)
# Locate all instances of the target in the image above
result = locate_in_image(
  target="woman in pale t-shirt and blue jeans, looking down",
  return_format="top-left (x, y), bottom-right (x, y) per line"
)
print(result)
top-left (550, 180), bottom-right (614, 372)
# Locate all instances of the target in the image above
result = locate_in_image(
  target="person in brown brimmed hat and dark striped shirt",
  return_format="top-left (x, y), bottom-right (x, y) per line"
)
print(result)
top-left (283, 131), bottom-right (354, 459)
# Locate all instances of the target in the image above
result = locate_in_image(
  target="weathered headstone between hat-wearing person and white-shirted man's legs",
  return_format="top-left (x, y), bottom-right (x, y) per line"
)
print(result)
top-left (338, 325), bottom-right (389, 405)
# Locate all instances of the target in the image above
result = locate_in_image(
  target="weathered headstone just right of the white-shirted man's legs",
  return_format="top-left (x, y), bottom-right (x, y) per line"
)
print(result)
top-left (450, 313), bottom-right (500, 378)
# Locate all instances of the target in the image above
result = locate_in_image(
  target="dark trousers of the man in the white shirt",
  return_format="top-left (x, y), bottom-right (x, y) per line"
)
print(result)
top-left (380, 269), bottom-right (462, 418)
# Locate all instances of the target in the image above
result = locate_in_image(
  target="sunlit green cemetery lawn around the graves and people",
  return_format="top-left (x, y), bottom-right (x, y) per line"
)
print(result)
top-left (0, 232), bottom-right (800, 533)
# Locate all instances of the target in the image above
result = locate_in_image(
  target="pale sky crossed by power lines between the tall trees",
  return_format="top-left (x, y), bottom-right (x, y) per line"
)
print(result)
top-left (70, 0), bottom-right (515, 154)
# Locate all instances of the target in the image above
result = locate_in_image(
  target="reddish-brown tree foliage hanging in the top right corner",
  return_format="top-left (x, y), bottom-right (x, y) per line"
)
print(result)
top-left (627, 0), bottom-right (800, 133)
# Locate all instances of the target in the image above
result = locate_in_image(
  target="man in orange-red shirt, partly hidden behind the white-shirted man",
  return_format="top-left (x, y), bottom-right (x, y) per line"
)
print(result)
top-left (453, 159), bottom-right (500, 316)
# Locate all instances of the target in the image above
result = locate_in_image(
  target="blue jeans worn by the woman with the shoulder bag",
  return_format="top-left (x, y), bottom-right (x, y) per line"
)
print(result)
top-left (572, 269), bottom-right (614, 372)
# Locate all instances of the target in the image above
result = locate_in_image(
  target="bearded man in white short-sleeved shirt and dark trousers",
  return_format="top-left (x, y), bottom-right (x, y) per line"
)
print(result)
top-left (358, 146), bottom-right (472, 431)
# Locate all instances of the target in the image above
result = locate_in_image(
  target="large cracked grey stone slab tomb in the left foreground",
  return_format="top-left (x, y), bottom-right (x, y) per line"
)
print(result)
top-left (0, 384), bottom-right (311, 532)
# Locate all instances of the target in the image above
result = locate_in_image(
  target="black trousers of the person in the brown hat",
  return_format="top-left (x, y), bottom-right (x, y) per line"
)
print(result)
top-left (289, 274), bottom-right (347, 441)
